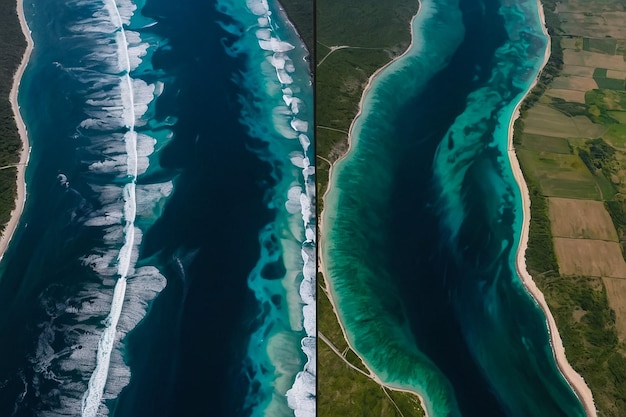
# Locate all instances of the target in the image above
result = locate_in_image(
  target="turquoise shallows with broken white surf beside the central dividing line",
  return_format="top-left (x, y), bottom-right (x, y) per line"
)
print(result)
top-left (221, 0), bottom-right (316, 416)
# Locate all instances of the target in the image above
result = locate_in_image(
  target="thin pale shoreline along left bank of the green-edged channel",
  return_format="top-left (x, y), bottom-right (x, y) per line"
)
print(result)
top-left (317, 4), bottom-right (429, 417)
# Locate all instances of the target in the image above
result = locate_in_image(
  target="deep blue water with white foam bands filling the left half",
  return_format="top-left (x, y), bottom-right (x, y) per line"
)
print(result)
top-left (0, 0), bottom-right (315, 417)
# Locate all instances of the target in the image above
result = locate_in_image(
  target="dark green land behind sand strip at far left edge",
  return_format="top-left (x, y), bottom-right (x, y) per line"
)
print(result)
top-left (0, 0), bottom-right (26, 231)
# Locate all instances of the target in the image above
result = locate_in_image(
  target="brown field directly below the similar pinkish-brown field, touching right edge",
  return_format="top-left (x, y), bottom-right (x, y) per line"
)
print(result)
top-left (554, 237), bottom-right (626, 278)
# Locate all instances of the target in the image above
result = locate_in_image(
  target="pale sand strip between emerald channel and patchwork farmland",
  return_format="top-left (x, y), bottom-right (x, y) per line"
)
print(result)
top-left (508, 0), bottom-right (597, 417)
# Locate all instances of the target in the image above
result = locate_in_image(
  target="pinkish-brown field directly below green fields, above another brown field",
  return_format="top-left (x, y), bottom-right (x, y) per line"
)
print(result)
top-left (548, 197), bottom-right (617, 242)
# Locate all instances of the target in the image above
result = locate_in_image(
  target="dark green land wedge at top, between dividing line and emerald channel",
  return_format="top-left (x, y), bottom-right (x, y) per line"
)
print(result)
top-left (315, 0), bottom-right (419, 205)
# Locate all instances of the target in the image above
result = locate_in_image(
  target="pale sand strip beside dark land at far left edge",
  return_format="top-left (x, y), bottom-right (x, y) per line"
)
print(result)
top-left (0, 0), bottom-right (34, 259)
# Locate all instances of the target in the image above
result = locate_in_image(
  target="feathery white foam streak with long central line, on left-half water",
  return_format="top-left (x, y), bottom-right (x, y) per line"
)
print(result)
top-left (22, 0), bottom-right (172, 417)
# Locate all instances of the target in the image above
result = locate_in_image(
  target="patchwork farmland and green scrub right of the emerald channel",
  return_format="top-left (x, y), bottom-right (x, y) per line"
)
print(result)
top-left (514, 0), bottom-right (626, 416)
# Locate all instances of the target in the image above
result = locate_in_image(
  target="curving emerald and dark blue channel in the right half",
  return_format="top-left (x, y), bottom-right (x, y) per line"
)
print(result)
top-left (321, 0), bottom-right (585, 417)
